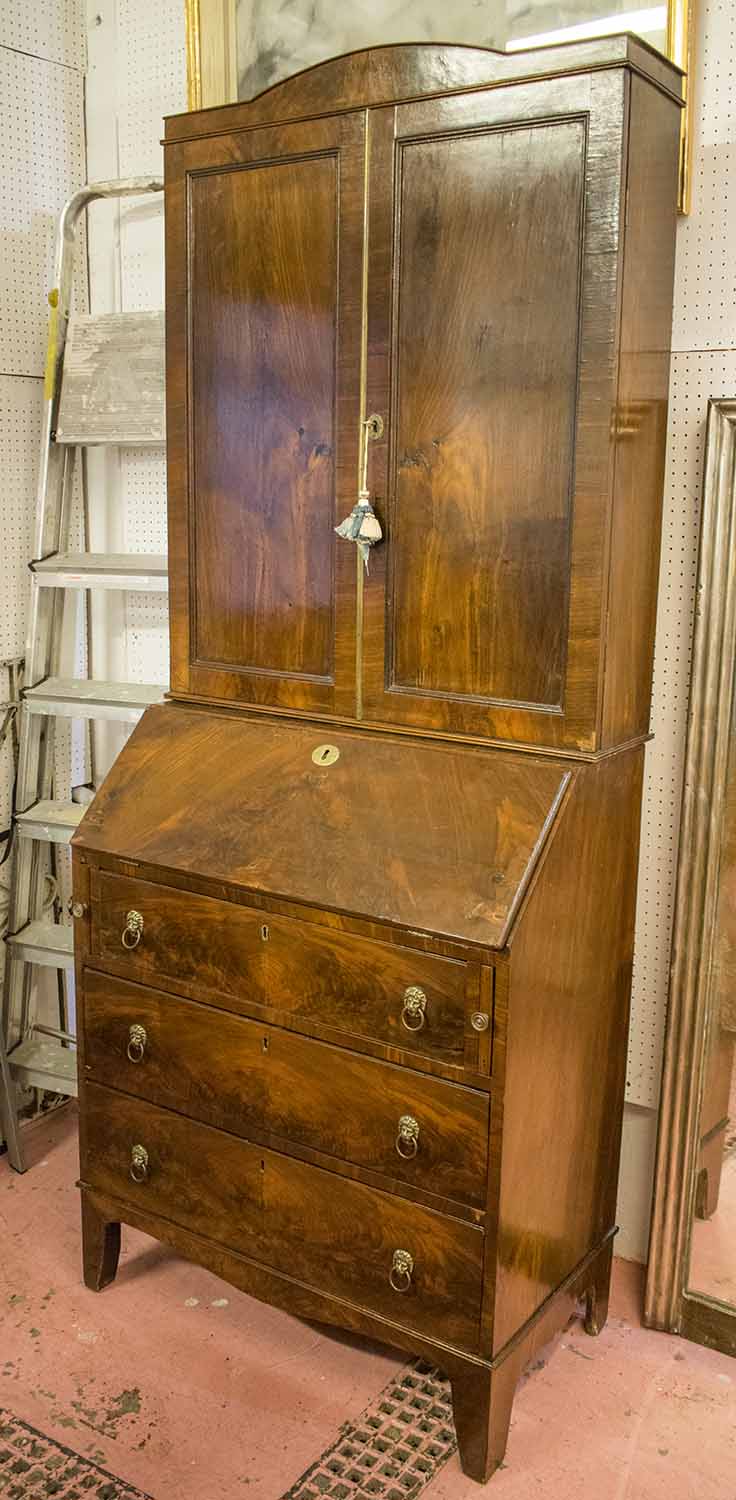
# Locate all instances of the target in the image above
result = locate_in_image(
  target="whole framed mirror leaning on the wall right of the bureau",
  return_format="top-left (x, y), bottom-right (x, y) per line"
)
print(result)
top-left (645, 401), bottom-right (736, 1355)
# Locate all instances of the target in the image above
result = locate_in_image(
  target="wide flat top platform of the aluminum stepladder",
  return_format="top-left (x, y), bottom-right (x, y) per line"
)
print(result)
top-left (55, 312), bottom-right (166, 446)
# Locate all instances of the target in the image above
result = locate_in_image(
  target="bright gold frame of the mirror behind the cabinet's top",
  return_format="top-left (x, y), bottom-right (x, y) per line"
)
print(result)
top-left (184, 0), bottom-right (696, 213)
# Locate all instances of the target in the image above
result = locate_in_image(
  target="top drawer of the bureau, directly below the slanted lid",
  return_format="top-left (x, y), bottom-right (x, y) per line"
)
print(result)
top-left (91, 873), bottom-right (472, 1065)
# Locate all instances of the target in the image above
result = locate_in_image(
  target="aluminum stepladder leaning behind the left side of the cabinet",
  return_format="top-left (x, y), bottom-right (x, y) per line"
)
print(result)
top-left (0, 177), bottom-right (168, 1172)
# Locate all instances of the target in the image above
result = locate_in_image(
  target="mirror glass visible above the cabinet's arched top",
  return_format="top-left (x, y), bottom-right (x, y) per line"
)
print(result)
top-left (235, 0), bottom-right (667, 99)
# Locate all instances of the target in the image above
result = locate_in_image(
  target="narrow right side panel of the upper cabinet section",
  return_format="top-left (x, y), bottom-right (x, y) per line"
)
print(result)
top-left (601, 78), bottom-right (679, 747)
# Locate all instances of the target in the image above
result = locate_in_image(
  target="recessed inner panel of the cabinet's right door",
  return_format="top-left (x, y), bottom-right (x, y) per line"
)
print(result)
top-left (390, 120), bottom-right (585, 707)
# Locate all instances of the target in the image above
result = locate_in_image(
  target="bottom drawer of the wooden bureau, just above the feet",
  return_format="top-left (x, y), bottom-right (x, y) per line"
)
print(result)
top-left (82, 1083), bottom-right (484, 1350)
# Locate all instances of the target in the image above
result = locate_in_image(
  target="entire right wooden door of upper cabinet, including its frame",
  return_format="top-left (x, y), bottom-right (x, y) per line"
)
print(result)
top-left (364, 74), bottom-right (625, 747)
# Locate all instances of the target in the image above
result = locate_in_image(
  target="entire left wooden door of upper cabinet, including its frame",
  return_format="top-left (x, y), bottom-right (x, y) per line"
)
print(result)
top-left (166, 114), bottom-right (364, 714)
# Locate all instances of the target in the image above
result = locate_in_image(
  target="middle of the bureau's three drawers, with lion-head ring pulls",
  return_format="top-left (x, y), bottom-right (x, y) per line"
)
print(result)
top-left (84, 969), bottom-right (489, 1208)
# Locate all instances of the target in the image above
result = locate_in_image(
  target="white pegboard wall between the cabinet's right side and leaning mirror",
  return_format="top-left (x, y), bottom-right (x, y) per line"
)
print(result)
top-left (627, 0), bottom-right (736, 1107)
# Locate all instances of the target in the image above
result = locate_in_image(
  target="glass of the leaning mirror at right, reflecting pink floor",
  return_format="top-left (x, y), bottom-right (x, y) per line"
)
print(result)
top-left (688, 723), bottom-right (736, 1307)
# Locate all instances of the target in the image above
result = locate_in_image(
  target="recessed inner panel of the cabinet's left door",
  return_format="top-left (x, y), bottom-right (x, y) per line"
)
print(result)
top-left (190, 155), bottom-right (339, 680)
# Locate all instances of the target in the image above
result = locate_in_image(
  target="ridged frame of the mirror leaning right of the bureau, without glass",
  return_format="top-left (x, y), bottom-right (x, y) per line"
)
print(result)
top-left (645, 401), bottom-right (736, 1355)
